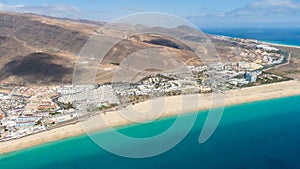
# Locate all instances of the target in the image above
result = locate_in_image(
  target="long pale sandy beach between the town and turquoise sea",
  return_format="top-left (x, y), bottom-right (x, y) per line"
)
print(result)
top-left (0, 80), bottom-right (300, 154)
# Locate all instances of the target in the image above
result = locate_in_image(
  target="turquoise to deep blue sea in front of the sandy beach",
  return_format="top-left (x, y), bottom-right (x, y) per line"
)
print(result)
top-left (0, 96), bottom-right (300, 169)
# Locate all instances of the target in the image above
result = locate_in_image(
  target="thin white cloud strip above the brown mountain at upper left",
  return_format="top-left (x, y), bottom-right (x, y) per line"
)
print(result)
top-left (0, 3), bottom-right (82, 18)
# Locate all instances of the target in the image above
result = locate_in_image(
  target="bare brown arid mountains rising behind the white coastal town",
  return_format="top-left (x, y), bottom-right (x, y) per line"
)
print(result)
top-left (0, 12), bottom-right (298, 85)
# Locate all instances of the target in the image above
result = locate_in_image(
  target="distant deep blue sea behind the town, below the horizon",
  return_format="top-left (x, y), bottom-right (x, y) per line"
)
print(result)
top-left (202, 28), bottom-right (300, 46)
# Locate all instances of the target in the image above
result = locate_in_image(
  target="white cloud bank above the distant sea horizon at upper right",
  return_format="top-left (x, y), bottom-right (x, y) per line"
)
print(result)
top-left (200, 0), bottom-right (300, 27)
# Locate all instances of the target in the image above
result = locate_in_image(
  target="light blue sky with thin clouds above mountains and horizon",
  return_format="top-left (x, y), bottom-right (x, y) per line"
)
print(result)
top-left (0, 0), bottom-right (300, 27)
